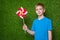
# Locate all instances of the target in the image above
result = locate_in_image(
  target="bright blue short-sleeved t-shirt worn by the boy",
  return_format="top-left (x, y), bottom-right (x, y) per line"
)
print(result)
top-left (31, 17), bottom-right (52, 40)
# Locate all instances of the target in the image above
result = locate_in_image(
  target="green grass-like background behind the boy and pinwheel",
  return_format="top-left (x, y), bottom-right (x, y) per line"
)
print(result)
top-left (0, 0), bottom-right (60, 40)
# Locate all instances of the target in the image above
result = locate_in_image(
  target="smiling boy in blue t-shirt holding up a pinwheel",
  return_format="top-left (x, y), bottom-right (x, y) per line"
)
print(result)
top-left (23, 3), bottom-right (52, 40)
